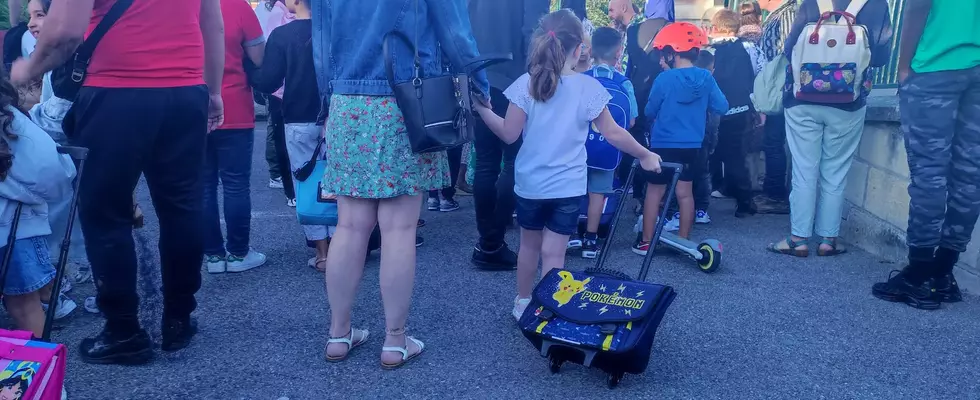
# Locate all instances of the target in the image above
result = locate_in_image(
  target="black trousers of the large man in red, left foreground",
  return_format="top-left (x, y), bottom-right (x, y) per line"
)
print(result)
top-left (72, 85), bottom-right (211, 328)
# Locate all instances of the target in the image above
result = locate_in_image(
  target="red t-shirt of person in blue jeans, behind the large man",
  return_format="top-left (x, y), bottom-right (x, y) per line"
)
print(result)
top-left (219, 0), bottom-right (265, 129)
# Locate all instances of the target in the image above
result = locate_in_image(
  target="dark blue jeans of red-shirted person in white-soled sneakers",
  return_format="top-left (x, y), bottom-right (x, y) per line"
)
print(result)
top-left (202, 128), bottom-right (255, 256)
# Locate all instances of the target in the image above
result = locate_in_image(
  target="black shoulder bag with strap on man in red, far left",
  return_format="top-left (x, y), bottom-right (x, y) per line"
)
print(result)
top-left (51, 0), bottom-right (133, 100)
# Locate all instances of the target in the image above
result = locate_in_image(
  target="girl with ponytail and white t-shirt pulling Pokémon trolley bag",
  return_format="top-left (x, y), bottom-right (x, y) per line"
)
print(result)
top-left (477, 10), bottom-right (660, 319)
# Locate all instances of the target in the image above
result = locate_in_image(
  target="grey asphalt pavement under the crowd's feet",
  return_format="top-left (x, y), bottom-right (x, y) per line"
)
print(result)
top-left (54, 129), bottom-right (980, 400)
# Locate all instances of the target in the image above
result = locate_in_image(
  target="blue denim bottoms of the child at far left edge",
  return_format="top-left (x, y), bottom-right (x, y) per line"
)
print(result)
top-left (0, 236), bottom-right (55, 296)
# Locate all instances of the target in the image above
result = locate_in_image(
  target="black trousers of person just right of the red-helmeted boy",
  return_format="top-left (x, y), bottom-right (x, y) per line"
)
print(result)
top-left (711, 113), bottom-right (753, 207)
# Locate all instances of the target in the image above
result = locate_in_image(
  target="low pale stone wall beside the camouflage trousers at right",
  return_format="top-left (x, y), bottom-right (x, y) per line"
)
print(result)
top-left (841, 92), bottom-right (980, 293)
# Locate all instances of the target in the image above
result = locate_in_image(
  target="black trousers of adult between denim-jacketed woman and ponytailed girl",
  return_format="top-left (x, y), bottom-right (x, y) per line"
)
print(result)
top-left (472, 88), bottom-right (521, 250)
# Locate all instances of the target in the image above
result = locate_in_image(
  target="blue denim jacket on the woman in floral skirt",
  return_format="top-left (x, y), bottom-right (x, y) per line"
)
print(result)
top-left (312, 0), bottom-right (490, 100)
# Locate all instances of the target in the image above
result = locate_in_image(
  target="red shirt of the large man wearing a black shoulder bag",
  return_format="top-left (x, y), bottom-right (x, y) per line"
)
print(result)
top-left (85, 0), bottom-right (206, 88)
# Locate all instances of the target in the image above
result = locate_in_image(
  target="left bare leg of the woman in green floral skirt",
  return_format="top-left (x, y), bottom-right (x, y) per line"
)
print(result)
top-left (326, 196), bottom-right (378, 357)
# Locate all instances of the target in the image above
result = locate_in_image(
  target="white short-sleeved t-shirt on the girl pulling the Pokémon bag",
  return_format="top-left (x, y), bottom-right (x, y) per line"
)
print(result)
top-left (504, 74), bottom-right (612, 199)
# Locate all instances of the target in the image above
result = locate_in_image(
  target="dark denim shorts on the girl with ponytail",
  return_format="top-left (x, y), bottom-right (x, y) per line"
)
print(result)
top-left (517, 196), bottom-right (582, 235)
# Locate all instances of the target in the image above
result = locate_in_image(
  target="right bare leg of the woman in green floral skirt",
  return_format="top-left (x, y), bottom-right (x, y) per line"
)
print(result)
top-left (378, 196), bottom-right (422, 364)
